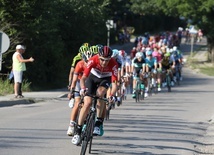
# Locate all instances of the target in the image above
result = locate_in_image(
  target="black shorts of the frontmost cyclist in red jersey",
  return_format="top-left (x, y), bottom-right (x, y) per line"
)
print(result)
top-left (85, 73), bottom-right (111, 95)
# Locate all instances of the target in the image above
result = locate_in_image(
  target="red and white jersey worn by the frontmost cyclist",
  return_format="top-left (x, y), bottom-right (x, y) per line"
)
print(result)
top-left (83, 55), bottom-right (118, 82)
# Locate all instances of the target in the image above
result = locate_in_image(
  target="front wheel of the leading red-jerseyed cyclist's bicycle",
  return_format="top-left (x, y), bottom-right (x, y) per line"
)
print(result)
top-left (80, 115), bottom-right (93, 155)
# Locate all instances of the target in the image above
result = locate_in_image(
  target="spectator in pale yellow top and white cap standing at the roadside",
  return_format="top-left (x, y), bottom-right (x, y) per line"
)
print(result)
top-left (12, 45), bottom-right (34, 98)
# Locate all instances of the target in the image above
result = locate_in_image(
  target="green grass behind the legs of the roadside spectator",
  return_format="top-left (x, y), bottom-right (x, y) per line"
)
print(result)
top-left (0, 79), bottom-right (31, 96)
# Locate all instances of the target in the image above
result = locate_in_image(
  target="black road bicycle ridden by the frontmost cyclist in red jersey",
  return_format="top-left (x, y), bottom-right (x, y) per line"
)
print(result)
top-left (80, 95), bottom-right (109, 155)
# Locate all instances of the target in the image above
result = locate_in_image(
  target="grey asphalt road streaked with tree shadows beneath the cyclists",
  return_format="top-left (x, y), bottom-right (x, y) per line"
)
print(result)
top-left (0, 38), bottom-right (214, 155)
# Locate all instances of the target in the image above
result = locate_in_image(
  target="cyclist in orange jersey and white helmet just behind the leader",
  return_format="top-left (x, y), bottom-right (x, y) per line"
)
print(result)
top-left (67, 48), bottom-right (92, 136)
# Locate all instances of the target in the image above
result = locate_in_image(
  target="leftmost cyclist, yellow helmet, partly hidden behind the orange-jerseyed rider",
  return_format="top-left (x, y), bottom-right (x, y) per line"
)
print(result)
top-left (68, 43), bottom-right (89, 90)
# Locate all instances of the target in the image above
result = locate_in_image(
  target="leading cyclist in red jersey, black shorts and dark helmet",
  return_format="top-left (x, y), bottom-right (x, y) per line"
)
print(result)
top-left (72, 46), bottom-right (118, 145)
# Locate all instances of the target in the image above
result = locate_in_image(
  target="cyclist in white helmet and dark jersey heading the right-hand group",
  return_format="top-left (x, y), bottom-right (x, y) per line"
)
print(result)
top-left (132, 52), bottom-right (145, 98)
